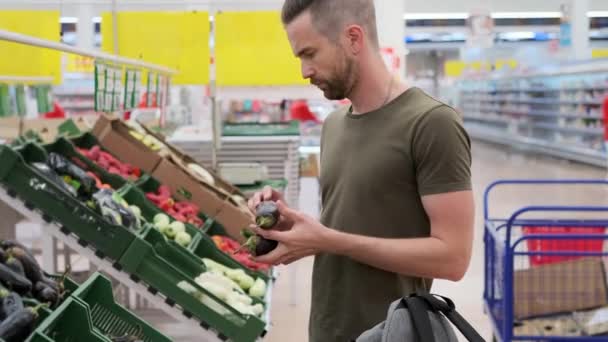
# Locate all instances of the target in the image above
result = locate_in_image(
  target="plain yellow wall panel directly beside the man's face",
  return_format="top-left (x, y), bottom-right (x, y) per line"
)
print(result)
top-left (215, 11), bottom-right (308, 86)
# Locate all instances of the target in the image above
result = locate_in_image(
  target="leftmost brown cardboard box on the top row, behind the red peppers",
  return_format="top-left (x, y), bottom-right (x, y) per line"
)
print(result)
top-left (92, 114), bottom-right (162, 174)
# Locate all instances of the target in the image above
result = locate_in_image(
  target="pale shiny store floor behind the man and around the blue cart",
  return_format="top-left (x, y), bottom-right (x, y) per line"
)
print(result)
top-left (140, 143), bottom-right (608, 342)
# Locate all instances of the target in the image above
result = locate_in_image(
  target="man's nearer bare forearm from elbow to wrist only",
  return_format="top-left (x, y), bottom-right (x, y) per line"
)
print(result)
top-left (322, 230), bottom-right (468, 281)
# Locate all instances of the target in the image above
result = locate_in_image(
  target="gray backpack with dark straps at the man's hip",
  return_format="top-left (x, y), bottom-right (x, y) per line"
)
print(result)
top-left (356, 294), bottom-right (484, 342)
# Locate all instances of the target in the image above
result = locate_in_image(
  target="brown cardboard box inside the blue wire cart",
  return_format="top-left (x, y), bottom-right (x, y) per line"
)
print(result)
top-left (513, 257), bottom-right (608, 319)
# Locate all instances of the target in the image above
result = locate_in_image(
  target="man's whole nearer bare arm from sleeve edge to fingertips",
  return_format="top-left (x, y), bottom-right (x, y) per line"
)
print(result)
top-left (252, 191), bottom-right (475, 281)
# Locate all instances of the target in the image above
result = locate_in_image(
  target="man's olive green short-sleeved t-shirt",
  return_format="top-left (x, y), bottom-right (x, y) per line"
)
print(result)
top-left (309, 88), bottom-right (471, 342)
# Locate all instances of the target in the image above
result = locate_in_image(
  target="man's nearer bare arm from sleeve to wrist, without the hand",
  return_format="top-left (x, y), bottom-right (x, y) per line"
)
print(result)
top-left (320, 191), bottom-right (475, 281)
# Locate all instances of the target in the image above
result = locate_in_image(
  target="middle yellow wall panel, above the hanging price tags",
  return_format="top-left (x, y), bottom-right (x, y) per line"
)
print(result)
top-left (101, 12), bottom-right (210, 84)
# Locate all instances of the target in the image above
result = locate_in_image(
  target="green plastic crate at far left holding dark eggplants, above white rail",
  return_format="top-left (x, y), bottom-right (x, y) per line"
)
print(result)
top-left (0, 143), bottom-right (135, 260)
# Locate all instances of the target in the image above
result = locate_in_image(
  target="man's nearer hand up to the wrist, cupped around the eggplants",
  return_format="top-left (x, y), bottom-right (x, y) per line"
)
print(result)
top-left (252, 201), bottom-right (330, 265)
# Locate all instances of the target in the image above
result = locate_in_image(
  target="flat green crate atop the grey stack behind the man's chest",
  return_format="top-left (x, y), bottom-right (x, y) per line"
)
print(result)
top-left (222, 121), bottom-right (300, 137)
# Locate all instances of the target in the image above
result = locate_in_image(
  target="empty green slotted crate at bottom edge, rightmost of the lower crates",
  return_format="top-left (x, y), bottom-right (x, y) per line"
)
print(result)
top-left (72, 273), bottom-right (171, 342)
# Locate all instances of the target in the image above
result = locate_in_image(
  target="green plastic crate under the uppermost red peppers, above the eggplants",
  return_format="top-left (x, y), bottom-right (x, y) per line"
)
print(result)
top-left (42, 138), bottom-right (128, 190)
